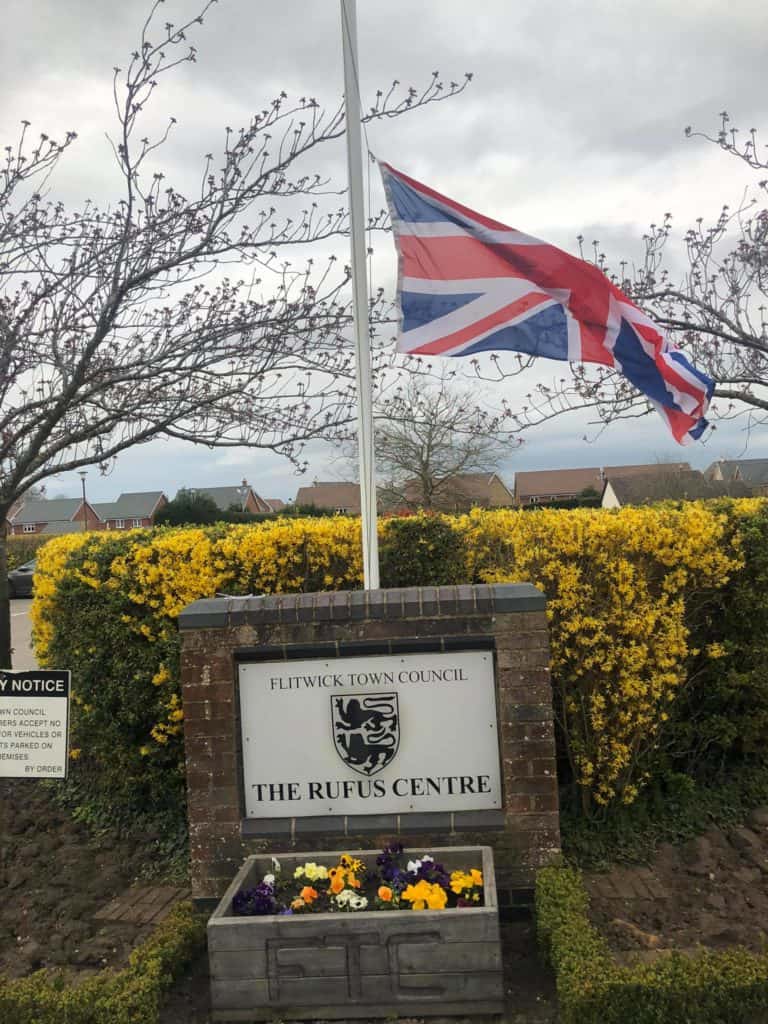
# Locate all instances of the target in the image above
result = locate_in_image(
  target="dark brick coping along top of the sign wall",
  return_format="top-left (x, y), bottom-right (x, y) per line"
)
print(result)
top-left (178, 583), bottom-right (547, 630)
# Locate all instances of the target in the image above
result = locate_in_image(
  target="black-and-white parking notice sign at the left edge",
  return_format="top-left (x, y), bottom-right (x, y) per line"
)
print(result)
top-left (0, 669), bottom-right (70, 778)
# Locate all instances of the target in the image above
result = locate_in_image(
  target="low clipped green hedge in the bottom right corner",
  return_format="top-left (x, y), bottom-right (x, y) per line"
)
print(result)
top-left (536, 867), bottom-right (768, 1024)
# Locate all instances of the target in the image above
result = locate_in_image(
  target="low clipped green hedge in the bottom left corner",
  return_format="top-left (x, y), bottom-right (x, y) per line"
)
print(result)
top-left (0, 903), bottom-right (205, 1024)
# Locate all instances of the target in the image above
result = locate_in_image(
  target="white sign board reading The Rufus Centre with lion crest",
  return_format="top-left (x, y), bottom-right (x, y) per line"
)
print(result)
top-left (240, 650), bottom-right (502, 818)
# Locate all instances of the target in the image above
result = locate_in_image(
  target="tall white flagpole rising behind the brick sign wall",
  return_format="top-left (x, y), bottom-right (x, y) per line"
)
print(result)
top-left (341, 0), bottom-right (379, 590)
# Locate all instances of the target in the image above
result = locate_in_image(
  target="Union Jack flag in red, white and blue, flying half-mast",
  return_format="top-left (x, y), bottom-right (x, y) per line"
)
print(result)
top-left (380, 163), bottom-right (715, 444)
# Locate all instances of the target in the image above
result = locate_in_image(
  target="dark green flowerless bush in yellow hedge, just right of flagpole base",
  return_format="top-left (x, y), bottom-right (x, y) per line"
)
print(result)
top-left (379, 514), bottom-right (467, 587)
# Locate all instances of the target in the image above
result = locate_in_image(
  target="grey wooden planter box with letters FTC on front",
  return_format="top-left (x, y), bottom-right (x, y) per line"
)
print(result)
top-left (208, 846), bottom-right (504, 1021)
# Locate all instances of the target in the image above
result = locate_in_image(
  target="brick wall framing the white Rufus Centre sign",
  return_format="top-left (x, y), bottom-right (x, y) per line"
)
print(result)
top-left (179, 584), bottom-right (559, 904)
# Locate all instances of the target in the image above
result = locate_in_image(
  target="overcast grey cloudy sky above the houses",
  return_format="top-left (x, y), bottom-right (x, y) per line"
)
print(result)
top-left (0, 0), bottom-right (768, 500)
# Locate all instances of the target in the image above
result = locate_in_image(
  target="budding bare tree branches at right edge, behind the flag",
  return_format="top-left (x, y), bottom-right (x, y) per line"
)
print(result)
top-left (477, 113), bottom-right (768, 440)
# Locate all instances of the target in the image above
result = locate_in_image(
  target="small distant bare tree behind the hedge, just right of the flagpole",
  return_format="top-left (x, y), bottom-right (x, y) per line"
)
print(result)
top-left (375, 373), bottom-right (519, 509)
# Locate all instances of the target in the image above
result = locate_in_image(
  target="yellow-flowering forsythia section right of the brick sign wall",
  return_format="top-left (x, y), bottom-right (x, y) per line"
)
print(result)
top-left (462, 503), bottom-right (740, 804)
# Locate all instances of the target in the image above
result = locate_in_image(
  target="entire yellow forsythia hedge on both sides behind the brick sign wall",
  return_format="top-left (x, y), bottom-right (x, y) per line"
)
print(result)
top-left (33, 500), bottom-right (765, 819)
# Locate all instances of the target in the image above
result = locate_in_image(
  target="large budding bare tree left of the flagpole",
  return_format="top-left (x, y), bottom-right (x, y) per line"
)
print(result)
top-left (0, 0), bottom-right (469, 666)
